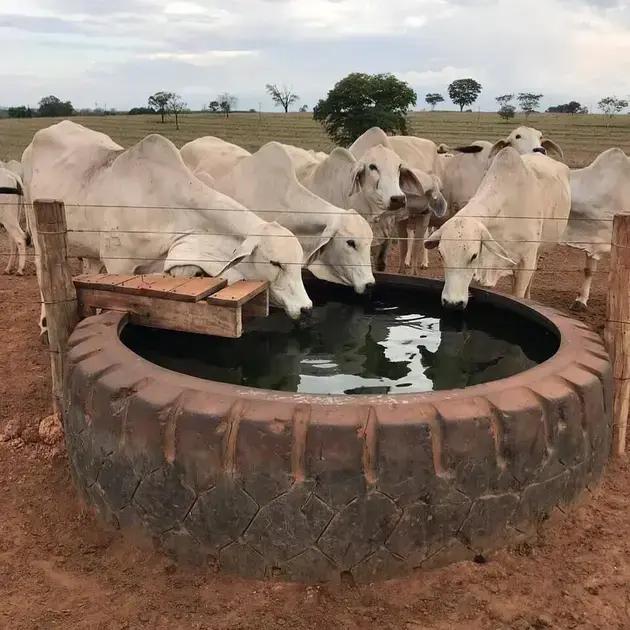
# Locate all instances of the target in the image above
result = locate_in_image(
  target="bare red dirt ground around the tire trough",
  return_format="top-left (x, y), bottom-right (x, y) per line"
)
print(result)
top-left (0, 243), bottom-right (630, 630)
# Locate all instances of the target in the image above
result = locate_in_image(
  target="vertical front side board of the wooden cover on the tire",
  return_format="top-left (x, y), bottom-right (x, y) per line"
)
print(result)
top-left (77, 287), bottom-right (243, 337)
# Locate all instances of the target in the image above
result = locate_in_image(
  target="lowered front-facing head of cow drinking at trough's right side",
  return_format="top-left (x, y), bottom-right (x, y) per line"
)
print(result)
top-left (424, 215), bottom-right (516, 310)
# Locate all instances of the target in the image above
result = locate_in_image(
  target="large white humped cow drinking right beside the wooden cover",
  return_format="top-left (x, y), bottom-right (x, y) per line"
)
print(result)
top-left (23, 121), bottom-right (312, 319)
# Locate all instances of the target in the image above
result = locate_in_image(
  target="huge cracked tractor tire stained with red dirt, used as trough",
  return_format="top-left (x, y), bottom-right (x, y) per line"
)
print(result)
top-left (65, 279), bottom-right (612, 582)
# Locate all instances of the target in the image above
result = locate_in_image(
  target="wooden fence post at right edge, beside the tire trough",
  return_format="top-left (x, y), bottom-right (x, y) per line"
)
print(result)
top-left (605, 214), bottom-right (630, 456)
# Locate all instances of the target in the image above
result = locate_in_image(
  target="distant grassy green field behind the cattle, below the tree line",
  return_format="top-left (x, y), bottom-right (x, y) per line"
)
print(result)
top-left (0, 112), bottom-right (630, 166)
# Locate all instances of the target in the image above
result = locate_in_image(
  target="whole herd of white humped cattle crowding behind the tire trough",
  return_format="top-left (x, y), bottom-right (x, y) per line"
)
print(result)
top-left (0, 121), bottom-right (630, 319)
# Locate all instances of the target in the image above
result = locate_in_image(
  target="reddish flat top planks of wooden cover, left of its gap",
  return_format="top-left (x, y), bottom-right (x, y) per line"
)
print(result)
top-left (74, 274), bottom-right (227, 302)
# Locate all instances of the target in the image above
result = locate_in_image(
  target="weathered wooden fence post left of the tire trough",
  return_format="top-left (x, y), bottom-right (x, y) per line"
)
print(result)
top-left (33, 199), bottom-right (79, 420)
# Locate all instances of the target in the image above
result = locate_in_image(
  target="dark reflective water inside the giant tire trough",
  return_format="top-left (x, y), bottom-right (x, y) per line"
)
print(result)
top-left (122, 285), bottom-right (558, 394)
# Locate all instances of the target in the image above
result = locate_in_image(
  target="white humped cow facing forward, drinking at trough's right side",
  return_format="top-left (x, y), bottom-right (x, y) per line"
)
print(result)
top-left (426, 148), bottom-right (571, 309)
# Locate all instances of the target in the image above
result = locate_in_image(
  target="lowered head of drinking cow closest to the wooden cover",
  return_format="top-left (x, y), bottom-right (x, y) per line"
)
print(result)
top-left (221, 222), bottom-right (313, 319)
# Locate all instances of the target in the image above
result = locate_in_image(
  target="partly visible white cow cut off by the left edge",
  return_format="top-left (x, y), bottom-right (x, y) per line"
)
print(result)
top-left (0, 167), bottom-right (27, 276)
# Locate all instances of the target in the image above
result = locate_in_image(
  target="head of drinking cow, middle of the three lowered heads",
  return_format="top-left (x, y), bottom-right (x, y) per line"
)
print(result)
top-left (306, 210), bottom-right (374, 294)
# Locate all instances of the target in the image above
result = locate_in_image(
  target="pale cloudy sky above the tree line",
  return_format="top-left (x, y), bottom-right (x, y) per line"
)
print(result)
top-left (0, 0), bottom-right (630, 110)
